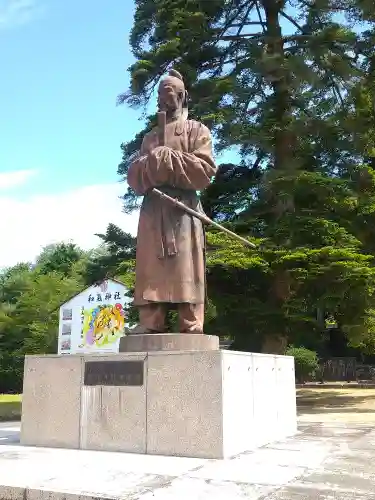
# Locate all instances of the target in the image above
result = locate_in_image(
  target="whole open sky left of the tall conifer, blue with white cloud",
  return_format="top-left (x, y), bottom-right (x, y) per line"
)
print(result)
top-left (0, 0), bottom-right (142, 267)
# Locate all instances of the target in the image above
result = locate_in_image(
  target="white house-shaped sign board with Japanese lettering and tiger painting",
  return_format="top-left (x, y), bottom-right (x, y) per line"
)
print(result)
top-left (58, 279), bottom-right (131, 354)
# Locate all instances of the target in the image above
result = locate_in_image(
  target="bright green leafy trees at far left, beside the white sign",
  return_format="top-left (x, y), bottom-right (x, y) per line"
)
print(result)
top-left (0, 244), bottom-right (88, 393)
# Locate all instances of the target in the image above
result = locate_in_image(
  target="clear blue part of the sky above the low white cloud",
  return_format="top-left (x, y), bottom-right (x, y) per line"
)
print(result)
top-left (0, 0), bottom-right (141, 195)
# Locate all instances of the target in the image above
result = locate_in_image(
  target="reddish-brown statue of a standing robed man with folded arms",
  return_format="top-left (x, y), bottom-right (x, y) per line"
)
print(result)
top-left (127, 70), bottom-right (216, 333)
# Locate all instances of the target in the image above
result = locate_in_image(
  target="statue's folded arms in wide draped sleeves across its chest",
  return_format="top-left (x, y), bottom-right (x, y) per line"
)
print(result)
top-left (127, 122), bottom-right (216, 195)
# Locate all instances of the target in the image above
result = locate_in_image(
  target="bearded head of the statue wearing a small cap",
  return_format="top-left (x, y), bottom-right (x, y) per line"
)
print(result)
top-left (158, 69), bottom-right (188, 118)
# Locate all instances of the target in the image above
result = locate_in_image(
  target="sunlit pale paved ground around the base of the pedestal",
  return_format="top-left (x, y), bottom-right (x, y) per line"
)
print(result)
top-left (0, 421), bottom-right (375, 500)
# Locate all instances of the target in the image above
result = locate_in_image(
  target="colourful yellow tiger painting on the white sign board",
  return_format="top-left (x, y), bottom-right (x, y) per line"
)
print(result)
top-left (80, 303), bottom-right (125, 348)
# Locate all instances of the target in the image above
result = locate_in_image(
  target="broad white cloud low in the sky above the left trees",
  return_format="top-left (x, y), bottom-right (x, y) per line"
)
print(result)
top-left (0, 183), bottom-right (138, 268)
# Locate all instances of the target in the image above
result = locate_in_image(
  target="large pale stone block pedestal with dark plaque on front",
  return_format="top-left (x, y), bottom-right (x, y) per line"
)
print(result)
top-left (21, 348), bottom-right (297, 458)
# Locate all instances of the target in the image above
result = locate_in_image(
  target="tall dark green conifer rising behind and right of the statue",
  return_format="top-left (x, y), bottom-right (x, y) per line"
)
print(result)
top-left (112, 0), bottom-right (375, 352)
